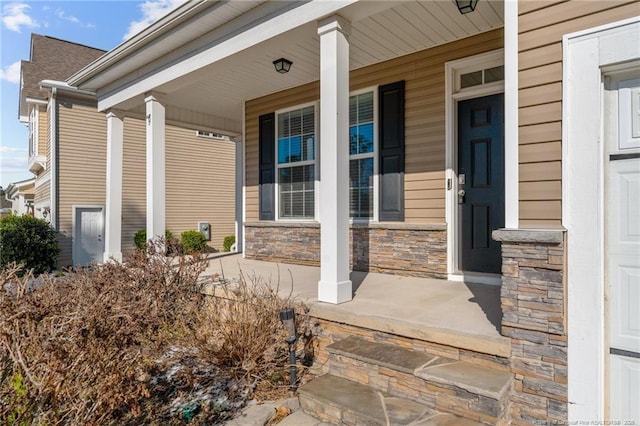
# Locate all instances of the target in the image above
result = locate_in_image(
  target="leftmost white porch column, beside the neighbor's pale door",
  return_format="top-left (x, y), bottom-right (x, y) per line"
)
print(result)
top-left (104, 110), bottom-right (124, 262)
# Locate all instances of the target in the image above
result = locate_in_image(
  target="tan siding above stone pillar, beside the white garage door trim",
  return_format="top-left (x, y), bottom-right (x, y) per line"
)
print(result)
top-left (518, 0), bottom-right (640, 227)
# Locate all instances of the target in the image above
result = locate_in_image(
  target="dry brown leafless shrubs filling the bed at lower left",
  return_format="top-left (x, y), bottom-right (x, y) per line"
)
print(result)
top-left (0, 241), bottom-right (316, 425)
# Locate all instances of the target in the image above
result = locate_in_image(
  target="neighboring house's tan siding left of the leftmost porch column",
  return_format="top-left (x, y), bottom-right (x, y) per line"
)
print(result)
top-left (57, 102), bottom-right (107, 266)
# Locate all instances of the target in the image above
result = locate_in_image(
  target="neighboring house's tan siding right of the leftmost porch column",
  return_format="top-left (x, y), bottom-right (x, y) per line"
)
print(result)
top-left (121, 118), bottom-right (235, 252)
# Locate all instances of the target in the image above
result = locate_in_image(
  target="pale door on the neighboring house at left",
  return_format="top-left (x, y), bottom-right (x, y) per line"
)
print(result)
top-left (73, 207), bottom-right (104, 266)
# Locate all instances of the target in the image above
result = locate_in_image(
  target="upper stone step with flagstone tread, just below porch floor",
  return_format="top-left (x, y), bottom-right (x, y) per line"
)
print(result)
top-left (327, 336), bottom-right (513, 424)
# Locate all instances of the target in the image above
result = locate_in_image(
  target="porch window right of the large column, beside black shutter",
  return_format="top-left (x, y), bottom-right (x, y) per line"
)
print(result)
top-left (349, 92), bottom-right (375, 219)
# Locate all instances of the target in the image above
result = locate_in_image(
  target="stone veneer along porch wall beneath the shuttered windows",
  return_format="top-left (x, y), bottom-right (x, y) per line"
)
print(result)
top-left (244, 222), bottom-right (447, 278)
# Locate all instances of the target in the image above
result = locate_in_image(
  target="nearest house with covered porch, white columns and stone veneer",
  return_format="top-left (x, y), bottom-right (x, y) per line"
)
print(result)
top-left (67, 0), bottom-right (640, 424)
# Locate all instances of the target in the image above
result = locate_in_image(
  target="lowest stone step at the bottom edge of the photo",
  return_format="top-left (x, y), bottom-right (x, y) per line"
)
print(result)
top-left (298, 374), bottom-right (480, 426)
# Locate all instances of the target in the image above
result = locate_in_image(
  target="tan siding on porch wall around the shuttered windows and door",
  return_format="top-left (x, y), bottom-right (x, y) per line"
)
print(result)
top-left (246, 30), bottom-right (503, 223)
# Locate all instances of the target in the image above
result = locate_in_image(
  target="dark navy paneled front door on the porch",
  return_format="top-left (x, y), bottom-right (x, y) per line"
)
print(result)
top-left (458, 94), bottom-right (504, 274)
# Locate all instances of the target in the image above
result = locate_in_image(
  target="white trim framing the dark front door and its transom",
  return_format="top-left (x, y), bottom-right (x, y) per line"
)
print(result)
top-left (445, 49), bottom-right (508, 285)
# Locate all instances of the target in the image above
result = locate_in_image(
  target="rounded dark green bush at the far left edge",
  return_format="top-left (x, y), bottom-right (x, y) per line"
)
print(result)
top-left (0, 215), bottom-right (60, 274)
